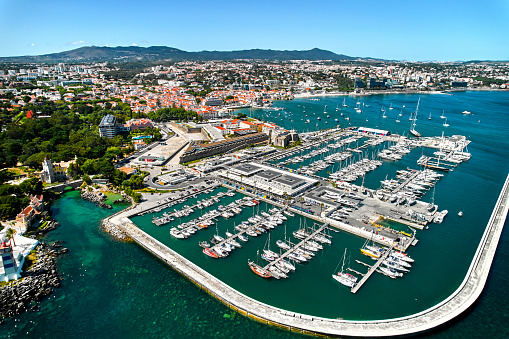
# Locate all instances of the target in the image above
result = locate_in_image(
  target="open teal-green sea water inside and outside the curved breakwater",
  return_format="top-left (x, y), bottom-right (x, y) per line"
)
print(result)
top-left (0, 92), bottom-right (509, 338)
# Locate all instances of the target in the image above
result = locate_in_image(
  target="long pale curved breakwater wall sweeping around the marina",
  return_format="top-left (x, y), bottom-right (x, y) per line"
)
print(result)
top-left (110, 176), bottom-right (509, 337)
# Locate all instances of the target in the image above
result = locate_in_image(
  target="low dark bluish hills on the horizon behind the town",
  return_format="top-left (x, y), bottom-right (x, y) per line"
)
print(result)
top-left (0, 46), bottom-right (374, 63)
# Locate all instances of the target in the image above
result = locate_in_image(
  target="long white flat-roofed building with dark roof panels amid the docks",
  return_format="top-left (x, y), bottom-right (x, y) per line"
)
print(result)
top-left (221, 162), bottom-right (318, 197)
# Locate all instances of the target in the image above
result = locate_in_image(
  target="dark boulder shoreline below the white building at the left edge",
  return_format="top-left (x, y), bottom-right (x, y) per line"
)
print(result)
top-left (0, 241), bottom-right (67, 323)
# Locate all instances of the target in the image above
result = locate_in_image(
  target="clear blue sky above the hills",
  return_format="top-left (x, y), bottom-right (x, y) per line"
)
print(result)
top-left (0, 0), bottom-right (509, 61)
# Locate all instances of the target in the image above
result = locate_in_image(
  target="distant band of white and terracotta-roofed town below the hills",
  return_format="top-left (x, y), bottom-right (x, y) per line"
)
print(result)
top-left (0, 60), bottom-right (509, 119)
